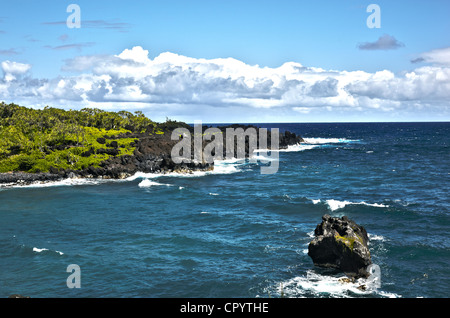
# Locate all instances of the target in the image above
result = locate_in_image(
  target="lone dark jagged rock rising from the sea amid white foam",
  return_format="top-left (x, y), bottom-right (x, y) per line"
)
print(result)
top-left (308, 214), bottom-right (372, 277)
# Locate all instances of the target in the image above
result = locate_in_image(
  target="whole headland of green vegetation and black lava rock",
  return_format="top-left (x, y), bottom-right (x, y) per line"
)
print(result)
top-left (0, 103), bottom-right (303, 184)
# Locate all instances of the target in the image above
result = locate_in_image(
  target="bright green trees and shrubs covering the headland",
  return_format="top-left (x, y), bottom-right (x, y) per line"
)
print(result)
top-left (0, 102), bottom-right (180, 173)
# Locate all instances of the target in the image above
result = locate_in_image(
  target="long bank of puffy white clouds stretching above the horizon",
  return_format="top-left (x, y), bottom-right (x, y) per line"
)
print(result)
top-left (0, 46), bottom-right (450, 121)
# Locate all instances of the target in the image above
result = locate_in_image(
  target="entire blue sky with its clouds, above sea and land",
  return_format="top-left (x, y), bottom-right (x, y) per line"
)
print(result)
top-left (0, 0), bottom-right (450, 123)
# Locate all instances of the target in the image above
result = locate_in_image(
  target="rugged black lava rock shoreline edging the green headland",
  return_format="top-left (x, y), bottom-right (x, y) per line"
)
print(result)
top-left (0, 126), bottom-right (305, 188)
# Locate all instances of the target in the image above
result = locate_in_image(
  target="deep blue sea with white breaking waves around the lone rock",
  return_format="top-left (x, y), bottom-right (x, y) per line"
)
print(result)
top-left (0, 123), bottom-right (450, 298)
